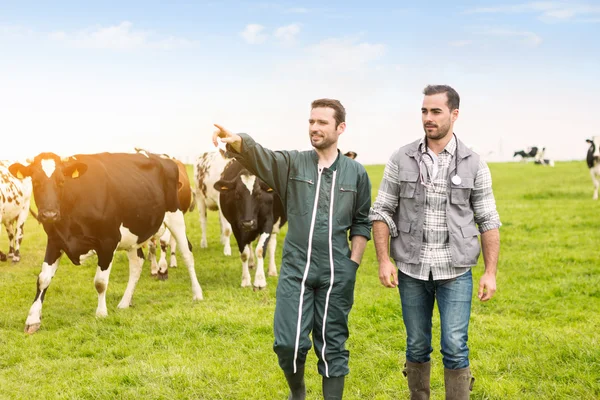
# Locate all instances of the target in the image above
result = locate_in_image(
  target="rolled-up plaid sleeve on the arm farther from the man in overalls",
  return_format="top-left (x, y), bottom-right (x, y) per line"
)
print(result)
top-left (471, 160), bottom-right (502, 233)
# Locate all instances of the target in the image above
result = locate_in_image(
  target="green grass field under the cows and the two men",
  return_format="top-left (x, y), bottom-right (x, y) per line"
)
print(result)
top-left (0, 161), bottom-right (600, 400)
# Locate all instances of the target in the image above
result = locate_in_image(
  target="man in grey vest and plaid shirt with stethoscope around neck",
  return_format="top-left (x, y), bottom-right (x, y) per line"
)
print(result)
top-left (369, 85), bottom-right (501, 399)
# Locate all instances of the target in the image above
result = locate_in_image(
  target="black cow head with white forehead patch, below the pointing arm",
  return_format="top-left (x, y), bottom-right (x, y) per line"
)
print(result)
top-left (214, 170), bottom-right (273, 232)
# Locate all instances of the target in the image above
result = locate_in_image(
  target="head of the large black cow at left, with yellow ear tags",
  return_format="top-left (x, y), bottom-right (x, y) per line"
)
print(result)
top-left (8, 153), bottom-right (87, 223)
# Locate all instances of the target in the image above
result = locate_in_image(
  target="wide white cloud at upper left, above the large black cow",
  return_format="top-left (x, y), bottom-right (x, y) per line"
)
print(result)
top-left (49, 21), bottom-right (195, 50)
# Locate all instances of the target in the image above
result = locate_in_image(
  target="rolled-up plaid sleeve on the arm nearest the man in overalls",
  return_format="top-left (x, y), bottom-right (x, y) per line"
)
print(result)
top-left (369, 153), bottom-right (400, 237)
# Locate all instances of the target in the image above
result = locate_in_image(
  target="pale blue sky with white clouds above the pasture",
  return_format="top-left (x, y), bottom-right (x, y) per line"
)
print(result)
top-left (0, 0), bottom-right (600, 164)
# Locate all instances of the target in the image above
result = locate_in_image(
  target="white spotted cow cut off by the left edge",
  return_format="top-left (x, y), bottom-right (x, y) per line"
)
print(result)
top-left (0, 161), bottom-right (32, 263)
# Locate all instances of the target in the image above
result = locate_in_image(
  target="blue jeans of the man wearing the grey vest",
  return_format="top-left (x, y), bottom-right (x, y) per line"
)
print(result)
top-left (398, 270), bottom-right (473, 369)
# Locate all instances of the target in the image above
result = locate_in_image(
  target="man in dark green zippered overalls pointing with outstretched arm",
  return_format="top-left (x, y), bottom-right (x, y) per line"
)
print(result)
top-left (213, 99), bottom-right (371, 400)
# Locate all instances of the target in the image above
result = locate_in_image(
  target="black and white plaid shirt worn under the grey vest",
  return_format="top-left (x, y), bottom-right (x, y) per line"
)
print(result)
top-left (369, 137), bottom-right (501, 280)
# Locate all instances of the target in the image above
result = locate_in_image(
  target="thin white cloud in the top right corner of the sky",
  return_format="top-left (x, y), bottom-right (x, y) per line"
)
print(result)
top-left (465, 1), bottom-right (600, 22)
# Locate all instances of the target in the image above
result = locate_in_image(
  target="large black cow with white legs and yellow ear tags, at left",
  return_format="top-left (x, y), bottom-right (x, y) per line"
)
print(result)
top-left (9, 153), bottom-right (202, 333)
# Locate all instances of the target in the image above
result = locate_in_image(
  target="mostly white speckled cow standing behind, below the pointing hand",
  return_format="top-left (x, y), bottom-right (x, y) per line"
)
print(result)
top-left (194, 151), bottom-right (233, 256)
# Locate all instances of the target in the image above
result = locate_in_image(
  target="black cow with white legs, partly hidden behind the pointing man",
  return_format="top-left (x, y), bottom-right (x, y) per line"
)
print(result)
top-left (214, 161), bottom-right (287, 289)
